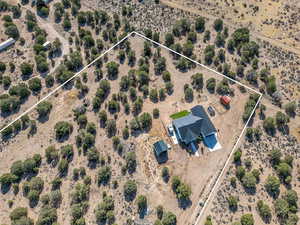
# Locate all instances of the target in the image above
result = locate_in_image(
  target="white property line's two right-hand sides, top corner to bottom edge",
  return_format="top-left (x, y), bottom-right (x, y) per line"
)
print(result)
top-left (133, 32), bottom-right (263, 225)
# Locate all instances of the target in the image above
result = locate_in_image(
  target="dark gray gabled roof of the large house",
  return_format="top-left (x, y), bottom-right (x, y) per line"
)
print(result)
top-left (173, 105), bottom-right (216, 144)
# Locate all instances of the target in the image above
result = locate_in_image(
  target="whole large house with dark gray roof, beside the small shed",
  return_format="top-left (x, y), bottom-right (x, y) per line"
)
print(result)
top-left (172, 105), bottom-right (218, 150)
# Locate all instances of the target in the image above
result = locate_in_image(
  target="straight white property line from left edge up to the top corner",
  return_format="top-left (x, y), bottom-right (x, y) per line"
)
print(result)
top-left (0, 32), bottom-right (133, 133)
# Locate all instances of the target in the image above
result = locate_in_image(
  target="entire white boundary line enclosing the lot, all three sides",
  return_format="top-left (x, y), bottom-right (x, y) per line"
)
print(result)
top-left (0, 31), bottom-right (263, 225)
